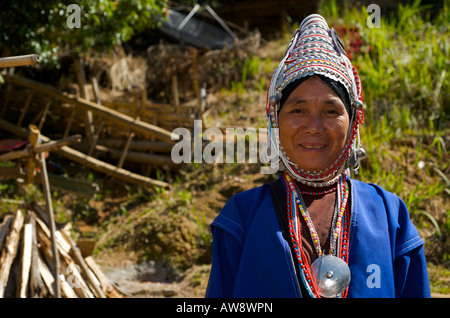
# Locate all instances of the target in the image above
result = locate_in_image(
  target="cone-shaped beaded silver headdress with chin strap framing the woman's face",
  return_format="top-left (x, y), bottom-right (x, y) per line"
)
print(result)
top-left (266, 14), bottom-right (364, 187)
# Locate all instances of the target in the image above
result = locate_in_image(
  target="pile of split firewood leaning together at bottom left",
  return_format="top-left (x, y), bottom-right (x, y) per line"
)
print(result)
top-left (0, 209), bottom-right (127, 298)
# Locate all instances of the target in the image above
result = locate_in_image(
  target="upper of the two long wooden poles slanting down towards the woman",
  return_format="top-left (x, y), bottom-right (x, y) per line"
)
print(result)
top-left (3, 75), bottom-right (179, 144)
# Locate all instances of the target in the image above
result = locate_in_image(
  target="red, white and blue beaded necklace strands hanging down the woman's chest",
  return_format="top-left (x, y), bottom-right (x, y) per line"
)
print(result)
top-left (283, 173), bottom-right (349, 298)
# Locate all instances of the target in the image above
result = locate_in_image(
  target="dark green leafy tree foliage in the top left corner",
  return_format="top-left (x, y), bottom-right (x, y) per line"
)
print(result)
top-left (0, 0), bottom-right (166, 64)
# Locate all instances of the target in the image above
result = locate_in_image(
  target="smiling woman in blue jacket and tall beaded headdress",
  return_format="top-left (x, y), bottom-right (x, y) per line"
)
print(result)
top-left (206, 14), bottom-right (430, 298)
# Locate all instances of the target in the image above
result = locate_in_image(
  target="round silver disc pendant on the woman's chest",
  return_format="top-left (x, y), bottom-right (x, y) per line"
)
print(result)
top-left (311, 255), bottom-right (351, 298)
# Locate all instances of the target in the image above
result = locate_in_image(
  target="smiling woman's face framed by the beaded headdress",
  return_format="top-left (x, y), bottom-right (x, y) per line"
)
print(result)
top-left (278, 76), bottom-right (349, 171)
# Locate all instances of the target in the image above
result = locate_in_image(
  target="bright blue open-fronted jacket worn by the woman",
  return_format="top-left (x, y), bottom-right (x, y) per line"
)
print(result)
top-left (206, 179), bottom-right (430, 298)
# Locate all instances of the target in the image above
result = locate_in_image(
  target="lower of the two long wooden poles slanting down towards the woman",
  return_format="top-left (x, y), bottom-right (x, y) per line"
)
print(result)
top-left (0, 119), bottom-right (171, 188)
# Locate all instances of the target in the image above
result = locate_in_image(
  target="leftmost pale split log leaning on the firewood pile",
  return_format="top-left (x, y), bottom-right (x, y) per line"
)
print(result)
top-left (0, 210), bottom-right (24, 298)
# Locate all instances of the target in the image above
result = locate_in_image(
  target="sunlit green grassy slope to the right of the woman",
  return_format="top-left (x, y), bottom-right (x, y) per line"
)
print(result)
top-left (322, 1), bottom-right (450, 261)
